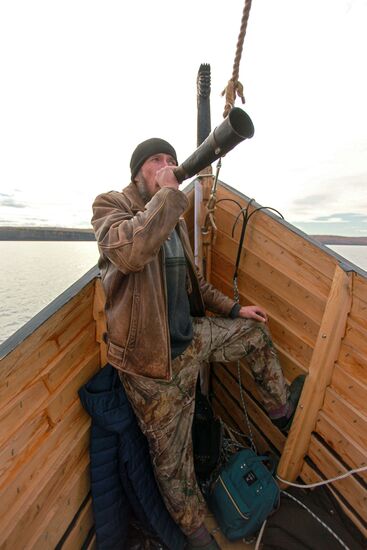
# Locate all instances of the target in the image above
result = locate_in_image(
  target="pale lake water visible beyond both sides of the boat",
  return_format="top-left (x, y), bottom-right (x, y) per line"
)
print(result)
top-left (0, 241), bottom-right (367, 343)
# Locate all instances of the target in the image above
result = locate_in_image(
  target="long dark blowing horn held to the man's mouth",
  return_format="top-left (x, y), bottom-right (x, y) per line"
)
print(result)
top-left (174, 107), bottom-right (255, 183)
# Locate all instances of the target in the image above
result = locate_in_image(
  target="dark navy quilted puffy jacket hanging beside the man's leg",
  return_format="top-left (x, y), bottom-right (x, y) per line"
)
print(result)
top-left (79, 365), bottom-right (186, 550)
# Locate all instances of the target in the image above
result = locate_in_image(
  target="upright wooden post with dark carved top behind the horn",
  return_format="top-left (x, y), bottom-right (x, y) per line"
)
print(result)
top-left (195, 63), bottom-right (212, 280)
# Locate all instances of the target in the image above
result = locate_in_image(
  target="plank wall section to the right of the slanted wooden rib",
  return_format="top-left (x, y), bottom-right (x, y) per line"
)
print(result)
top-left (301, 273), bottom-right (367, 536)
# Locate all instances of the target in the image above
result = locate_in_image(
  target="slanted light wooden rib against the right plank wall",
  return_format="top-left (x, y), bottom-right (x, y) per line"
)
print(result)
top-left (277, 266), bottom-right (352, 481)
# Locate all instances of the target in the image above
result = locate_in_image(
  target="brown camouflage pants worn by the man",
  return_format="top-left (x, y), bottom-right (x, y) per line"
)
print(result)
top-left (120, 317), bottom-right (288, 535)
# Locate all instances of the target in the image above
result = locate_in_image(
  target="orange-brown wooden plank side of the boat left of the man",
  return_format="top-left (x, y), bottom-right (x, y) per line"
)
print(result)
top-left (0, 280), bottom-right (101, 550)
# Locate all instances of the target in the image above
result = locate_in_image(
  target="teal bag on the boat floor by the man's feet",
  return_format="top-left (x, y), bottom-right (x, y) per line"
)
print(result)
top-left (208, 449), bottom-right (280, 541)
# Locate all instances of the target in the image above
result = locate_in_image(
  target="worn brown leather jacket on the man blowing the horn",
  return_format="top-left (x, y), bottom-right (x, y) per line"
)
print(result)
top-left (92, 183), bottom-right (235, 380)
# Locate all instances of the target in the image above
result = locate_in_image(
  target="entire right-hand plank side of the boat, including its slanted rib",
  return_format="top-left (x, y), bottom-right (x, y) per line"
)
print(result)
top-left (211, 186), bottom-right (367, 534)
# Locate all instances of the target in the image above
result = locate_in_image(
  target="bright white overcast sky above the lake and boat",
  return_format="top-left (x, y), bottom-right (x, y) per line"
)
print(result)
top-left (0, 0), bottom-right (367, 236)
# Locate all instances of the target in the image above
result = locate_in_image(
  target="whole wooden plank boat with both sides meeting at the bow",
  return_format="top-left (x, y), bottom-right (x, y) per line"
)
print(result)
top-left (0, 66), bottom-right (367, 550)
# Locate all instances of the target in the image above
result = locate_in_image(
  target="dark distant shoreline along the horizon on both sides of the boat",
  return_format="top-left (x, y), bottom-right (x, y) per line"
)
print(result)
top-left (0, 226), bottom-right (367, 246)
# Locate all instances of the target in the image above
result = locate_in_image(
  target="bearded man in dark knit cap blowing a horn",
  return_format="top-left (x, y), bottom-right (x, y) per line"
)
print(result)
top-left (92, 138), bottom-right (300, 549)
